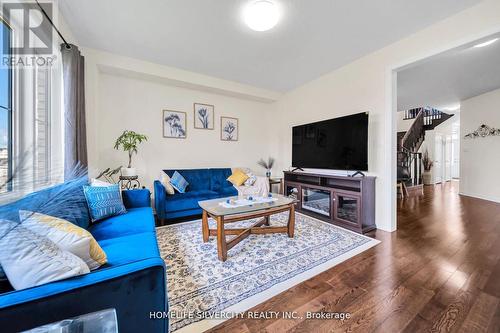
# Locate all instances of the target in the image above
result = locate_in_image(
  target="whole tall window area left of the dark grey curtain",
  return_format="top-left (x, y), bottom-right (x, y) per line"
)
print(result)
top-left (0, 8), bottom-right (64, 205)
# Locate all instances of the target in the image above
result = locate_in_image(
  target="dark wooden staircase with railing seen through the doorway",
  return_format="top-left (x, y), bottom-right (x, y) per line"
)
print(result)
top-left (397, 108), bottom-right (453, 186)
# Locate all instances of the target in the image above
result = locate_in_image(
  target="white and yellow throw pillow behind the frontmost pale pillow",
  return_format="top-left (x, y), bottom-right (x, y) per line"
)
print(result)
top-left (19, 210), bottom-right (107, 270)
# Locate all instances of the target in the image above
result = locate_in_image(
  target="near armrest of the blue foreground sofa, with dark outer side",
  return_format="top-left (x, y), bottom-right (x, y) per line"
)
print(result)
top-left (0, 258), bottom-right (168, 332)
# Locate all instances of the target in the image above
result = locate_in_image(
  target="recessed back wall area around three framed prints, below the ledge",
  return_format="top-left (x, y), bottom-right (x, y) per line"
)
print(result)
top-left (93, 73), bottom-right (271, 188)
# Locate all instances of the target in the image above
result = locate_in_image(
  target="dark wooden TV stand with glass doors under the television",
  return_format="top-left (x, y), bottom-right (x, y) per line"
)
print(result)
top-left (284, 171), bottom-right (376, 233)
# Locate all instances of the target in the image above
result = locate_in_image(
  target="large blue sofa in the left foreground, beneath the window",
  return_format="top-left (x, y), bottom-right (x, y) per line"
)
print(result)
top-left (0, 179), bottom-right (168, 332)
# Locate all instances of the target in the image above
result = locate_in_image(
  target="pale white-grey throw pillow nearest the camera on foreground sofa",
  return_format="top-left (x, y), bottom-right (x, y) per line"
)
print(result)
top-left (0, 221), bottom-right (89, 290)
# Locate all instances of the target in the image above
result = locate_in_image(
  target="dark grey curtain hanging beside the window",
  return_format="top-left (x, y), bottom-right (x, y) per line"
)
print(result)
top-left (61, 44), bottom-right (87, 180)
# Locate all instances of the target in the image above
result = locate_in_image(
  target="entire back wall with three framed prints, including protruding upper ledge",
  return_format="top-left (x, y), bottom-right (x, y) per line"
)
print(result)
top-left (84, 48), bottom-right (281, 189)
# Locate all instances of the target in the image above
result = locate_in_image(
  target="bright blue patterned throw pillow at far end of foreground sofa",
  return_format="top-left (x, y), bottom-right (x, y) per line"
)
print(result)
top-left (83, 185), bottom-right (127, 222)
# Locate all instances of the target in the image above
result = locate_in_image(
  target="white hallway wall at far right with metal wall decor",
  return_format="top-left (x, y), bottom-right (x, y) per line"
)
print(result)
top-left (460, 89), bottom-right (500, 202)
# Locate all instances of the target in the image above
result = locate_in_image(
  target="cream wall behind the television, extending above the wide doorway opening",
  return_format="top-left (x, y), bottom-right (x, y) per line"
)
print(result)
top-left (274, 0), bottom-right (500, 231)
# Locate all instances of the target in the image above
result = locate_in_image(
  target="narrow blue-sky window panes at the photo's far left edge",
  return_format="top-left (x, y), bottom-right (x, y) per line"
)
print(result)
top-left (0, 21), bottom-right (12, 193)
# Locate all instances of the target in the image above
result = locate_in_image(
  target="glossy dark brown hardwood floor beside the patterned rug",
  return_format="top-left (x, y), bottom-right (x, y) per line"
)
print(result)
top-left (211, 182), bottom-right (500, 333)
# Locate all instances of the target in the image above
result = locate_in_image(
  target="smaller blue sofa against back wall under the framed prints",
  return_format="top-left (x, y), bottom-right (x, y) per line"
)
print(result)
top-left (154, 168), bottom-right (238, 221)
